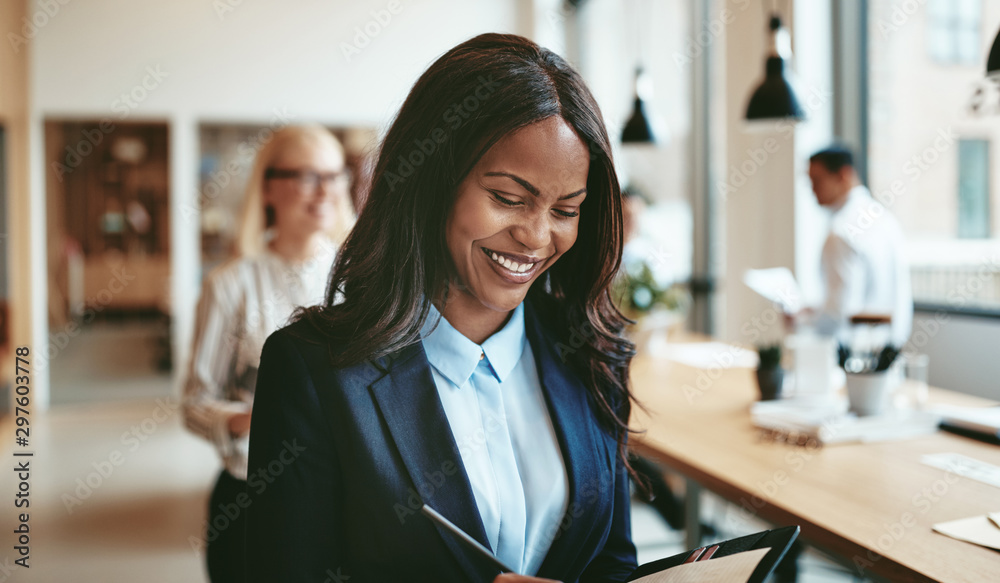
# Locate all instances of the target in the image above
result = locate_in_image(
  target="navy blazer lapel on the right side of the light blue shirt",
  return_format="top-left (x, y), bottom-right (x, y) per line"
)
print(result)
top-left (525, 303), bottom-right (613, 580)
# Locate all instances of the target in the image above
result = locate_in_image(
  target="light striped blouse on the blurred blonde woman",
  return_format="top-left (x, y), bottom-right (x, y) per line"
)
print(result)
top-left (183, 240), bottom-right (336, 480)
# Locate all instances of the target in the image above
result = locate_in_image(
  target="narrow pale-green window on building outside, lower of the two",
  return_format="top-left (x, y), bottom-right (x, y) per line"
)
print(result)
top-left (958, 140), bottom-right (990, 239)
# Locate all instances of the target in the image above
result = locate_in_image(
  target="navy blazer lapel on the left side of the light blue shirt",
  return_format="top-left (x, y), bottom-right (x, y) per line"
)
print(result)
top-left (369, 342), bottom-right (496, 580)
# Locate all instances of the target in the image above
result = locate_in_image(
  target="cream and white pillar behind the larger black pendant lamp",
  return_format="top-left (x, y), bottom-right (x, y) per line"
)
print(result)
top-left (713, 0), bottom-right (833, 343)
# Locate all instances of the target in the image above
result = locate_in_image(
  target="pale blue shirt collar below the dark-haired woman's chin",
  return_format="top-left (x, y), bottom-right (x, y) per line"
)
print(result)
top-left (420, 302), bottom-right (527, 387)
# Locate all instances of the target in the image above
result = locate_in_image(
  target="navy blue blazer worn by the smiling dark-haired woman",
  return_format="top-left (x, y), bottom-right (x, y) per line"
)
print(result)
top-left (246, 302), bottom-right (636, 583)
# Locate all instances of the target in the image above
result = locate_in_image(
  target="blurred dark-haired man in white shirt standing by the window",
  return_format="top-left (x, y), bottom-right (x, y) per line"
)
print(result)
top-left (809, 146), bottom-right (913, 347)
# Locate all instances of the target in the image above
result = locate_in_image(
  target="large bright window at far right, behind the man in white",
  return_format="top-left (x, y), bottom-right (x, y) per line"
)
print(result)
top-left (868, 0), bottom-right (1000, 309)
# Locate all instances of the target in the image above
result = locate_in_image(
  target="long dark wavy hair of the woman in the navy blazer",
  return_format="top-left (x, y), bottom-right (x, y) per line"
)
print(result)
top-left (296, 34), bottom-right (635, 470)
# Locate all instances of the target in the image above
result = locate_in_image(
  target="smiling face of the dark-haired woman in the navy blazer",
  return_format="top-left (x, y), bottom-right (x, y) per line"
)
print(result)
top-left (446, 116), bottom-right (590, 312)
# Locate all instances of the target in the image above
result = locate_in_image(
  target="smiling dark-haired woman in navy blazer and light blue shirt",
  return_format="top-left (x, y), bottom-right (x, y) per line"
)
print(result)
top-left (246, 34), bottom-right (635, 581)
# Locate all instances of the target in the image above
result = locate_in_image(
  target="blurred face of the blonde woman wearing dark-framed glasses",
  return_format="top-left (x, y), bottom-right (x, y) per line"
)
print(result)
top-left (264, 140), bottom-right (349, 234)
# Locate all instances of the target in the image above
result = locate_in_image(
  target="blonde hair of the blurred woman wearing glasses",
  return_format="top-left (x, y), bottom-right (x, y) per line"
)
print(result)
top-left (235, 125), bottom-right (355, 256)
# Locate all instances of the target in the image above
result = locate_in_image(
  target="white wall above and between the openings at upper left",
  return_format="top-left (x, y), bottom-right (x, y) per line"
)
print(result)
top-left (30, 0), bottom-right (524, 406)
